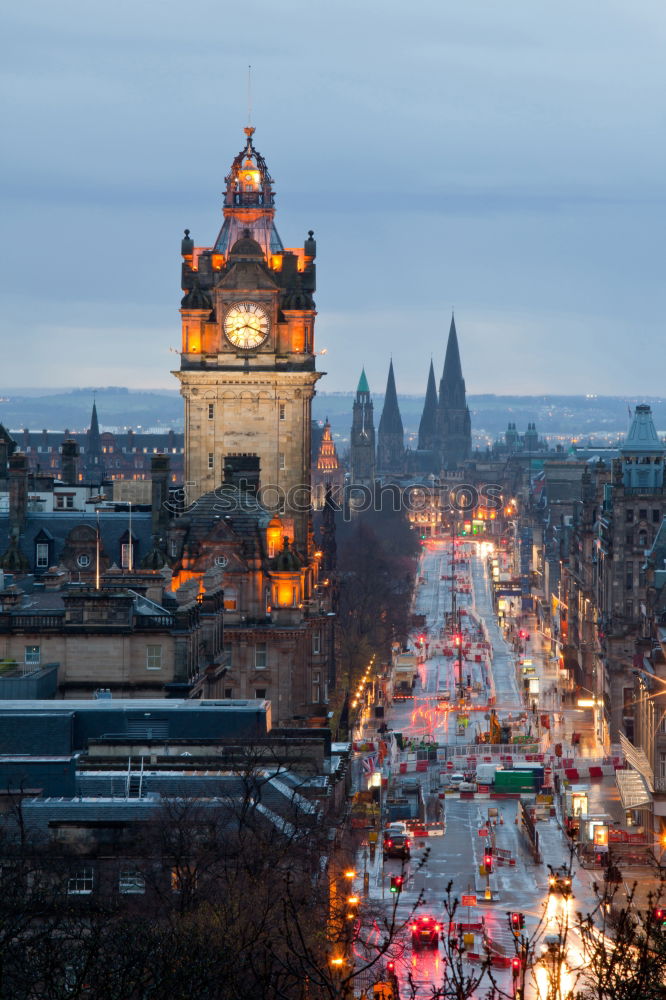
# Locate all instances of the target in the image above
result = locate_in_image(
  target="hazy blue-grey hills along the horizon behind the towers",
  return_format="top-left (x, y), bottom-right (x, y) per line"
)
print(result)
top-left (0, 386), bottom-right (666, 445)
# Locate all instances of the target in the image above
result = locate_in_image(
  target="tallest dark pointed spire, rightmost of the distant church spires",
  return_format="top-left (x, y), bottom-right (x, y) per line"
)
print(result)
top-left (437, 316), bottom-right (472, 469)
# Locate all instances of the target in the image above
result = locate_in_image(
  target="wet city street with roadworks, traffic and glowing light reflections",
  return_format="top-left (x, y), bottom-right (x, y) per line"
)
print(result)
top-left (364, 541), bottom-right (608, 998)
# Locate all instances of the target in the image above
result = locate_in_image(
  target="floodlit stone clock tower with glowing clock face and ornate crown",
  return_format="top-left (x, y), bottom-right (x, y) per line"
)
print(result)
top-left (174, 128), bottom-right (322, 555)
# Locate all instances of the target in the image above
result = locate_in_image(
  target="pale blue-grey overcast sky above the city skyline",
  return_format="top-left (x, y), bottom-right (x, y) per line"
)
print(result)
top-left (0, 0), bottom-right (666, 395)
